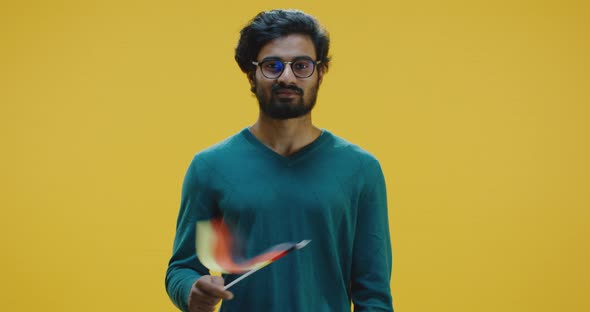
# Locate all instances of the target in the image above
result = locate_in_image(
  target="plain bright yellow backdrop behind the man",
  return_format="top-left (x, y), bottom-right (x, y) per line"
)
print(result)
top-left (0, 0), bottom-right (590, 312)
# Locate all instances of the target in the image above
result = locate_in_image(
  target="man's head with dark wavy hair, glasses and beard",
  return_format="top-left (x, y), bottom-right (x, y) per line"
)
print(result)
top-left (235, 10), bottom-right (330, 119)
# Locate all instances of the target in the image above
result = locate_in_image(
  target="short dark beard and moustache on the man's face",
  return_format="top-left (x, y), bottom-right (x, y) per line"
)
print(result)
top-left (256, 83), bottom-right (318, 120)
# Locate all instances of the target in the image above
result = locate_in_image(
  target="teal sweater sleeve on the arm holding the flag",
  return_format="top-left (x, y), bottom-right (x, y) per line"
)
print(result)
top-left (165, 158), bottom-right (219, 311)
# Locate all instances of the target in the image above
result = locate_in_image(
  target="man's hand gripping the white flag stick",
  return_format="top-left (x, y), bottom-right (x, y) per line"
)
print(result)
top-left (188, 275), bottom-right (234, 312)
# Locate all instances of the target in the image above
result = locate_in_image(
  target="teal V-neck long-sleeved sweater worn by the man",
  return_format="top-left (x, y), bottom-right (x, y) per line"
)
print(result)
top-left (166, 128), bottom-right (393, 312)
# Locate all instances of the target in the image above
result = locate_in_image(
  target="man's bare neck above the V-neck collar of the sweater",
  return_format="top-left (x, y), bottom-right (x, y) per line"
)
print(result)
top-left (250, 113), bottom-right (321, 157)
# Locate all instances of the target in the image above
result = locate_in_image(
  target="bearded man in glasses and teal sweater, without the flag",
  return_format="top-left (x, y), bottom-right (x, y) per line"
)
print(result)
top-left (166, 10), bottom-right (393, 312)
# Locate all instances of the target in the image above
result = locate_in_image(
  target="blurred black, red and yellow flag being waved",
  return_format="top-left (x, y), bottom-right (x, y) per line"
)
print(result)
top-left (196, 218), bottom-right (309, 274)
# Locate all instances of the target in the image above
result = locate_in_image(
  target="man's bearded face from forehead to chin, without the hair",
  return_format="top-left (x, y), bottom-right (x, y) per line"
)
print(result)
top-left (250, 34), bottom-right (322, 119)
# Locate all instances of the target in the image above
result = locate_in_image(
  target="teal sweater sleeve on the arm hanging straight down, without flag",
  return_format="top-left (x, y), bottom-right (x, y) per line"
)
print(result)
top-left (351, 160), bottom-right (393, 312)
